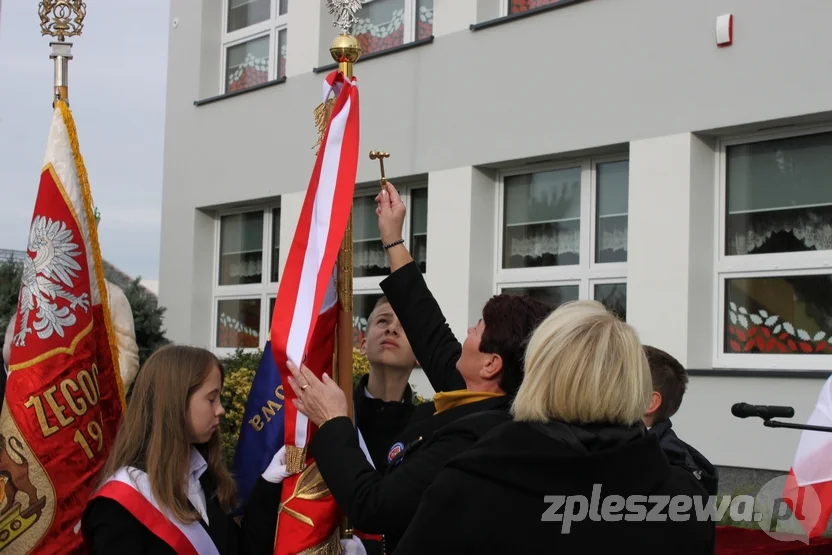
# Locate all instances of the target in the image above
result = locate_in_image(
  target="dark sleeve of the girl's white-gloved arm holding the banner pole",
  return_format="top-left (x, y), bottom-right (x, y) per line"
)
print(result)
top-left (240, 476), bottom-right (282, 555)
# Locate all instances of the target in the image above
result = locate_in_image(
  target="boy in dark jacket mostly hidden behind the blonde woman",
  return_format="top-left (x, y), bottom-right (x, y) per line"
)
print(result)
top-left (642, 345), bottom-right (719, 495)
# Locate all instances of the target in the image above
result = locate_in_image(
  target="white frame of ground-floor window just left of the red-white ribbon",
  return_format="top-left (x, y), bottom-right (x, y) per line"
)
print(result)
top-left (210, 199), bottom-right (282, 358)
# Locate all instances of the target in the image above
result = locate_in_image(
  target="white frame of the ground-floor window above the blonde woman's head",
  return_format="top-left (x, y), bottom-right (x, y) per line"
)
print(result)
top-left (494, 153), bottom-right (630, 306)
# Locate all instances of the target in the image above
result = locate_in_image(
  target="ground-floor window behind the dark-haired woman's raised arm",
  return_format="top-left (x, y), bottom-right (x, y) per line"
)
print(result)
top-left (352, 184), bottom-right (428, 347)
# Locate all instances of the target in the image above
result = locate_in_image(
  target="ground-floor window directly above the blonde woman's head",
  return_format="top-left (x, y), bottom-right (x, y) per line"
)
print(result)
top-left (496, 158), bottom-right (630, 319)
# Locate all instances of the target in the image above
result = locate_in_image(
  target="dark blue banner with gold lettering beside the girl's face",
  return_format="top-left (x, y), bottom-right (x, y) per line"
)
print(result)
top-left (234, 341), bottom-right (285, 513)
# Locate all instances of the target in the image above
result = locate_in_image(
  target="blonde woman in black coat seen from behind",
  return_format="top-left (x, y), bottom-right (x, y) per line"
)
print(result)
top-left (395, 301), bottom-right (715, 555)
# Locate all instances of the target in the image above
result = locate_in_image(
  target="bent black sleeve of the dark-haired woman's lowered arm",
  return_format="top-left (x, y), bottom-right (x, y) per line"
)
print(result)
top-left (310, 417), bottom-right (471, 536)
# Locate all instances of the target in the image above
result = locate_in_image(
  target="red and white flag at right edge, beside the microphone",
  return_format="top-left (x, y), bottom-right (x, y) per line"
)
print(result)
top-left (783, 377), bottom-right (832, 538)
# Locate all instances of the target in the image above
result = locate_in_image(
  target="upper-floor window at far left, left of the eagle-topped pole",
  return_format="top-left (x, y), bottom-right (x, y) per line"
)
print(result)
top-left (221, 0), bottom-right (289, 93)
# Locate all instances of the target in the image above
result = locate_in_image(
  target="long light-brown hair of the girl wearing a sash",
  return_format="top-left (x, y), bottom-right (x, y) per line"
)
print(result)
top-left (101, 345), bottom-right (236, 524)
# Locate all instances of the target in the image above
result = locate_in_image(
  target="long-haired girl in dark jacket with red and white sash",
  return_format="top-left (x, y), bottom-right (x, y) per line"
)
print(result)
top-left (82, 345), bottom-right (286, 555)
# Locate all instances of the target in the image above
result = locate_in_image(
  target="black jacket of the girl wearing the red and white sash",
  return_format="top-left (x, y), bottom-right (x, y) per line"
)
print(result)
top-left (82, 472), bottom-right (281, 555)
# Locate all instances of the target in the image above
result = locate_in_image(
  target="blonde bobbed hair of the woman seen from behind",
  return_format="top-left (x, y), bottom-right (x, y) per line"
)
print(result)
top-left (512, 301), bottom-right (653, 426)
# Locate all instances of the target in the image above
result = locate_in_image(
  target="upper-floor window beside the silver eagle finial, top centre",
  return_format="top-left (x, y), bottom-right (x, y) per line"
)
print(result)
top-left (352, 0), bottom-right (433, 56)
